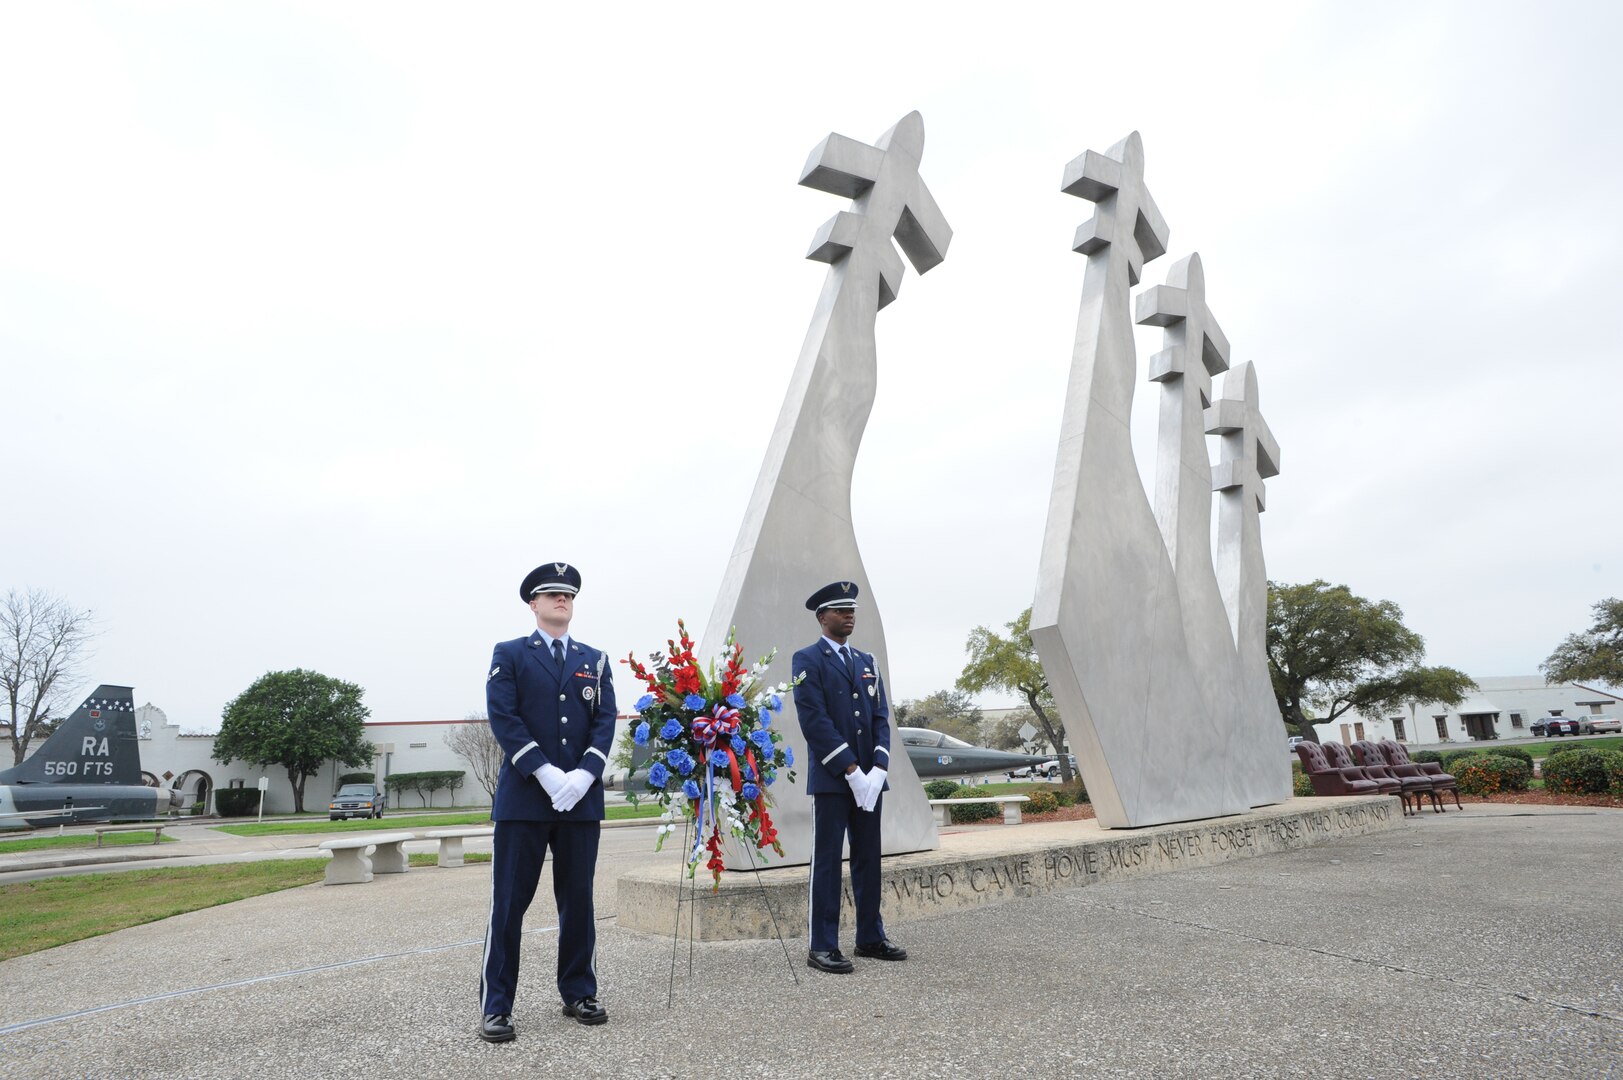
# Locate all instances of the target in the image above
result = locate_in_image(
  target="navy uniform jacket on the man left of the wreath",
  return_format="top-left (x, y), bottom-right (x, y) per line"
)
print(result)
top-left (485, 630), bottom-right (615, 822)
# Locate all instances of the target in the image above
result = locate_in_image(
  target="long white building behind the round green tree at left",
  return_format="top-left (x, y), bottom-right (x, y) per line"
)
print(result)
top-left (135, 705), bottom-right (626, 814)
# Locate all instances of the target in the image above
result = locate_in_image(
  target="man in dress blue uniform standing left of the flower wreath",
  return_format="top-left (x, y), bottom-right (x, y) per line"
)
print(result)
top-left (479, 562), bottom-right (615, 1043)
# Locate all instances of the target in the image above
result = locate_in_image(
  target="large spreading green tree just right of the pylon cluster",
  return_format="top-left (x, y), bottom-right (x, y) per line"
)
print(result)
top-left (1268, 580), bottom-right (1477, 742)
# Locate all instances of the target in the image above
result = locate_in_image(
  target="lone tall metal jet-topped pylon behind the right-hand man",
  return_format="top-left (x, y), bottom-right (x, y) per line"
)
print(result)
top-left (703, 112), bottom-right (953, 869)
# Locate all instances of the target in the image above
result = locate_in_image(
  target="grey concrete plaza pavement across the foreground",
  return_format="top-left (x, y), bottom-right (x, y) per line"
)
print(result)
top-left (0, 804), bottom-right (1623, 1080)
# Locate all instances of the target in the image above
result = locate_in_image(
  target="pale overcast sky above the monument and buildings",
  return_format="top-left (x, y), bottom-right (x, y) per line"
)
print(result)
top-left (0, 2), bottom-right (1623, 729)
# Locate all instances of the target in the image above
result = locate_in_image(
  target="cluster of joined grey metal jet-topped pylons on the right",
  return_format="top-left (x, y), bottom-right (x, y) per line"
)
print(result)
top-left (1031, 132), bottom-right (1289, 827)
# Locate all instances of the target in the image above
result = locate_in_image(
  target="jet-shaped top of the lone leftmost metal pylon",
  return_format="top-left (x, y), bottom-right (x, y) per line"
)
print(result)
top-left (800, 112), bottom-right (953, 307)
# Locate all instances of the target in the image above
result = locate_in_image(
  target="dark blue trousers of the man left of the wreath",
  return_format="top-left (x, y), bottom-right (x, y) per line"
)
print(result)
top-left (479, 822), bottom-right (601, 1017)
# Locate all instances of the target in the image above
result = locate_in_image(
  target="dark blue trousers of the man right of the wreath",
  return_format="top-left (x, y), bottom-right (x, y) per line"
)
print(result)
top-left (807, 791), bottom-right (885, 952)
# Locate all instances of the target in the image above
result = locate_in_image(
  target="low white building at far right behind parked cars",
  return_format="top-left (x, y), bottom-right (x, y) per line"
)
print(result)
top-left (1313, 676), bottom-right (1623, 745)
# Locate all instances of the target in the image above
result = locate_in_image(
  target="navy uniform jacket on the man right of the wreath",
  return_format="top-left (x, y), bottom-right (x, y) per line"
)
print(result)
top-left (794, 638), bottom-right (891, 796)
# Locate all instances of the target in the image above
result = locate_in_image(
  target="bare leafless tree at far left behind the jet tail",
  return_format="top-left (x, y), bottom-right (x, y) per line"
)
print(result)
top-left (0, 590), bottom-right (96, 765)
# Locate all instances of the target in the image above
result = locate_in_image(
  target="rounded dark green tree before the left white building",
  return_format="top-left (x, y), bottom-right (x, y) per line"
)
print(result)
top-left (214, 667), bottom-right (375, 814)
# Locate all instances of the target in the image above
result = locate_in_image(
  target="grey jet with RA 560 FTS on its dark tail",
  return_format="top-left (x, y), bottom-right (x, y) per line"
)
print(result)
top-left (0, 685), bottom-right (182, 828)
